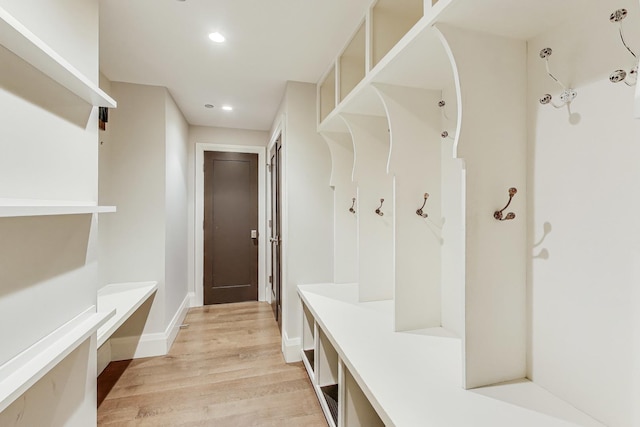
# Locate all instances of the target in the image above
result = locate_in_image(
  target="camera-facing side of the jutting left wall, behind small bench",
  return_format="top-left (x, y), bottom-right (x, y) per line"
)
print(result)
top-left (100, 82), bottom-right (166, 336)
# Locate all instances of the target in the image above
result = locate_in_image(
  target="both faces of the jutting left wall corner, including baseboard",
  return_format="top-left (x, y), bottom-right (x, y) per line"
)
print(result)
top-left (100, 78), bottom-right (189, 360)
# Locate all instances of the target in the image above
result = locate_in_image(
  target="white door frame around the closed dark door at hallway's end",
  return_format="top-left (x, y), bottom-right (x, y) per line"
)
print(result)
top-left (193, 143), bottom-right (269, 307)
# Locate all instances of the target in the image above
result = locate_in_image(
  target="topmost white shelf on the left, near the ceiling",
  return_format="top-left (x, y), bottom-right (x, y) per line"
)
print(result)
top-left (0, 7), bottom-right (117, 108)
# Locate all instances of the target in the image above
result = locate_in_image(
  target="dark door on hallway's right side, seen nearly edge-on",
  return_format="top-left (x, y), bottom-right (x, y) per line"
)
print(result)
top-left (269, 138), bottom-right (282, 330)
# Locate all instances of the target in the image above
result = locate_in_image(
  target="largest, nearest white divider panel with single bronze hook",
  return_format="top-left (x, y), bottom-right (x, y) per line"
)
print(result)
top-left (438, 25), bottom-right (527, 388)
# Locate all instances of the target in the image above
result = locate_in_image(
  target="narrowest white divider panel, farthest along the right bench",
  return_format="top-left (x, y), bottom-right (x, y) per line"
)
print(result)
top-left (321, 132), bottom-right (358, 283)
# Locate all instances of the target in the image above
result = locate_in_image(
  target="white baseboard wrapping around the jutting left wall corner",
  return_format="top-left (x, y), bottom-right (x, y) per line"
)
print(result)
top-left (109, 295), bottom-right (190, 361)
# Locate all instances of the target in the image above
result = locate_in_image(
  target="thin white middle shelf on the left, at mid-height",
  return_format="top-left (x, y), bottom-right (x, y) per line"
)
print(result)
top-left (0, 199), bottom-right (116, 218)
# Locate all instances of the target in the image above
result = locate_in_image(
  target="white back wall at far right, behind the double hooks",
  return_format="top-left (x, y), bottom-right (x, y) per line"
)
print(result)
top-left (527, 0), bottom-right (640, 427)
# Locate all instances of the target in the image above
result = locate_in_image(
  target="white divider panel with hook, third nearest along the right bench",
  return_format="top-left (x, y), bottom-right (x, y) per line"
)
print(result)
top-left (342, 114), bottom-right (394, 302)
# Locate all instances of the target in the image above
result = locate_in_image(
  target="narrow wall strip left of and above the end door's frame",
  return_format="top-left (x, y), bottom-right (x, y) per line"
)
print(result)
top-left (187, 126), bottom-right (269, 306)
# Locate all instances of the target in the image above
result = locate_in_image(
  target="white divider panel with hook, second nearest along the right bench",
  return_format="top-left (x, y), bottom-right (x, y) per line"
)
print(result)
top-left (374, 85), bottom-right (442, 331)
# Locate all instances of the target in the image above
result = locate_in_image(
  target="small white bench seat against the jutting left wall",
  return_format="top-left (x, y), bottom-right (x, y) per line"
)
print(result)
top-left (98, 282), bottom-right (158, 348)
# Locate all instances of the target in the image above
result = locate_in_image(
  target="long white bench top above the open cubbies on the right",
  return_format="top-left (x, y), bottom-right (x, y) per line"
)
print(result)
top-left (298, 284), bottom-right (603, 427)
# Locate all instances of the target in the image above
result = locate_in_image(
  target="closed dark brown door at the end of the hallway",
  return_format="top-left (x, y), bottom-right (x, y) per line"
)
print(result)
top-left (204, 151), bottom-right (258, 304)
